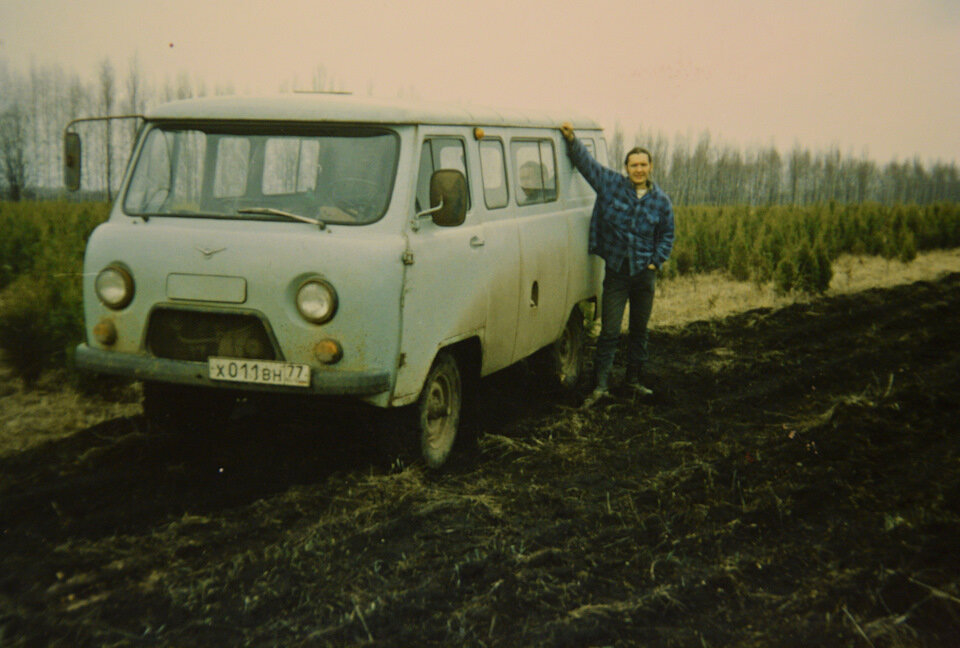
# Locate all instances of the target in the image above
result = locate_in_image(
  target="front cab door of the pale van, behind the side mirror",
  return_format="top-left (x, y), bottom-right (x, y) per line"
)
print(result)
top-left (393, 132), bottom-right (487, 405)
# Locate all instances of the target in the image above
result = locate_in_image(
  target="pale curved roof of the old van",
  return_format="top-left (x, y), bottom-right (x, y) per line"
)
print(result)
top-left (147, 93), bottom-right (600, 129)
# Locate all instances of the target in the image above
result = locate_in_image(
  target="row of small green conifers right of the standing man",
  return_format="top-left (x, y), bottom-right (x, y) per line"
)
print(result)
top-left (664, 203), bottom-right (960, 293)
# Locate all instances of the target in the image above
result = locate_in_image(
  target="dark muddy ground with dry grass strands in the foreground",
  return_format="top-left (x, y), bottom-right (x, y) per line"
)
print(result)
top-left (0, 274), bottom-right (960, 647)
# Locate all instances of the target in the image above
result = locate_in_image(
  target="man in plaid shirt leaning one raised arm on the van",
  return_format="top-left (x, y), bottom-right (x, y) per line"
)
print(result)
top-left (560, 122), bottom-right (673, 406)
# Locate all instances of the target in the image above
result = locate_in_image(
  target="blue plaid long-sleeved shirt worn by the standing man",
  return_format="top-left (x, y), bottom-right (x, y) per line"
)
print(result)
top-left (567, 138), bottom-right (673, 275)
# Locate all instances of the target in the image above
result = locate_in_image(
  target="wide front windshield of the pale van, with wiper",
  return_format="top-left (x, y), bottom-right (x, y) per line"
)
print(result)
top-left (123, 123), bottom-right (398, 225)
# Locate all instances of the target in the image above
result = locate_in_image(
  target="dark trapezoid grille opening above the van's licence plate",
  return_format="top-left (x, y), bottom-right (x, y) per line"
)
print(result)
top-left (147, 308), bottom-right (277, 362)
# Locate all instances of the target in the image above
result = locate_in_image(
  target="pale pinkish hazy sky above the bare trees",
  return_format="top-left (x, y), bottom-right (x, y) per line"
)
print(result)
top-left (0, 0), bottom-right (960, 162)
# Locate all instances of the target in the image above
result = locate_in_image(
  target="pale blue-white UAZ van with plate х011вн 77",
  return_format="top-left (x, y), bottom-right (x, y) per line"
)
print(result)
top-left (65, 94), bottom-right (606, 467)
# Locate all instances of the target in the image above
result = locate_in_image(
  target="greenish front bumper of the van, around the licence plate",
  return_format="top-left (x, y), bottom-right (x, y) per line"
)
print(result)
top-left (74, 344), bottom-right (390, 396)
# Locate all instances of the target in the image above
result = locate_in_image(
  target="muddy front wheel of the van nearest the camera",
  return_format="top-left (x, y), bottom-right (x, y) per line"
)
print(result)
top-left (417, 351), bottom-right (463, 468)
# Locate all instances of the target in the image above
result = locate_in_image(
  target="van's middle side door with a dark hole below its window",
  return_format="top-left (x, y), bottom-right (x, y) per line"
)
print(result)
top-left (510, 139), bottom-right (570, 360)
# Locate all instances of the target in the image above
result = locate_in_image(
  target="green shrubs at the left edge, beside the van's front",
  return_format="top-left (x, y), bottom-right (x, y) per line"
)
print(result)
top-left (0, 202), bottom-right (110, 382)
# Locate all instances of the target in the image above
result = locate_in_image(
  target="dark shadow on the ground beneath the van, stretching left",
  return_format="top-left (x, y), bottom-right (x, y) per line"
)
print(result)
top-left (0, 367), bottom-right (568, 544)
